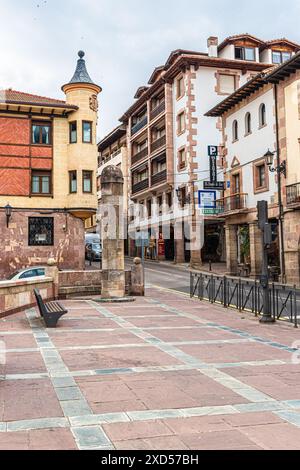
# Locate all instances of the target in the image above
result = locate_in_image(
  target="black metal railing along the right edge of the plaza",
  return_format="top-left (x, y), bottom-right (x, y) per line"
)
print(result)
top-left (190, 271), bottom-right (300, 328)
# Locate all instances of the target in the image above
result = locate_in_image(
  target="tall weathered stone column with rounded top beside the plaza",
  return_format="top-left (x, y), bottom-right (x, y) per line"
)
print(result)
top-left (100, 165), bottom-right (125, 299)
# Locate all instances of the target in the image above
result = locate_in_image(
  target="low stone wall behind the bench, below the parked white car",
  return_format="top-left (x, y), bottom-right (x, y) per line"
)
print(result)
top-left (0, 277), bottom-right (55, 318)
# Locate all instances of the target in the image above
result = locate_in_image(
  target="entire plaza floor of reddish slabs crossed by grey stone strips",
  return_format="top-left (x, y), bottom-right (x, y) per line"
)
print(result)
top-left (0, 288), bottom-right (300, 450)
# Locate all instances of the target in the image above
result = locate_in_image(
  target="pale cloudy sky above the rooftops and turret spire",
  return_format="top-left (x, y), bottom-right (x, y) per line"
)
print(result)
top-left (0, 0), bottom-right (300, 137)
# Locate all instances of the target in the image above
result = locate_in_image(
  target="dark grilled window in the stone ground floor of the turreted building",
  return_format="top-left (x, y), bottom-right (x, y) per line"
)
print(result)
top-left (28, 217), bottom-right (54, 246)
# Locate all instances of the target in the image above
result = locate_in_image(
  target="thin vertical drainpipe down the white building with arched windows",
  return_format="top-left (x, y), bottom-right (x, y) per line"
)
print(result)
top-left (274, 83), bottom-right (286, 283)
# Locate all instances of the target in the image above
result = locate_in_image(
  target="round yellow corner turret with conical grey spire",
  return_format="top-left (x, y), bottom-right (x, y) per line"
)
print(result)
top-left (62, 51), bottom-right (102, 219)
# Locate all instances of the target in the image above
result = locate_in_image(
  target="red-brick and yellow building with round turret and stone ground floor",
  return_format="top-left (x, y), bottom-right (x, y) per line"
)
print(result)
top-left (0, 52), bottom-right (101, 279)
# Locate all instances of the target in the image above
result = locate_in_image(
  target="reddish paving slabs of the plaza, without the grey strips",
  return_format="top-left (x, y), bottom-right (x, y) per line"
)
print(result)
top-left (0, 289), bottom-right (300, 450)
